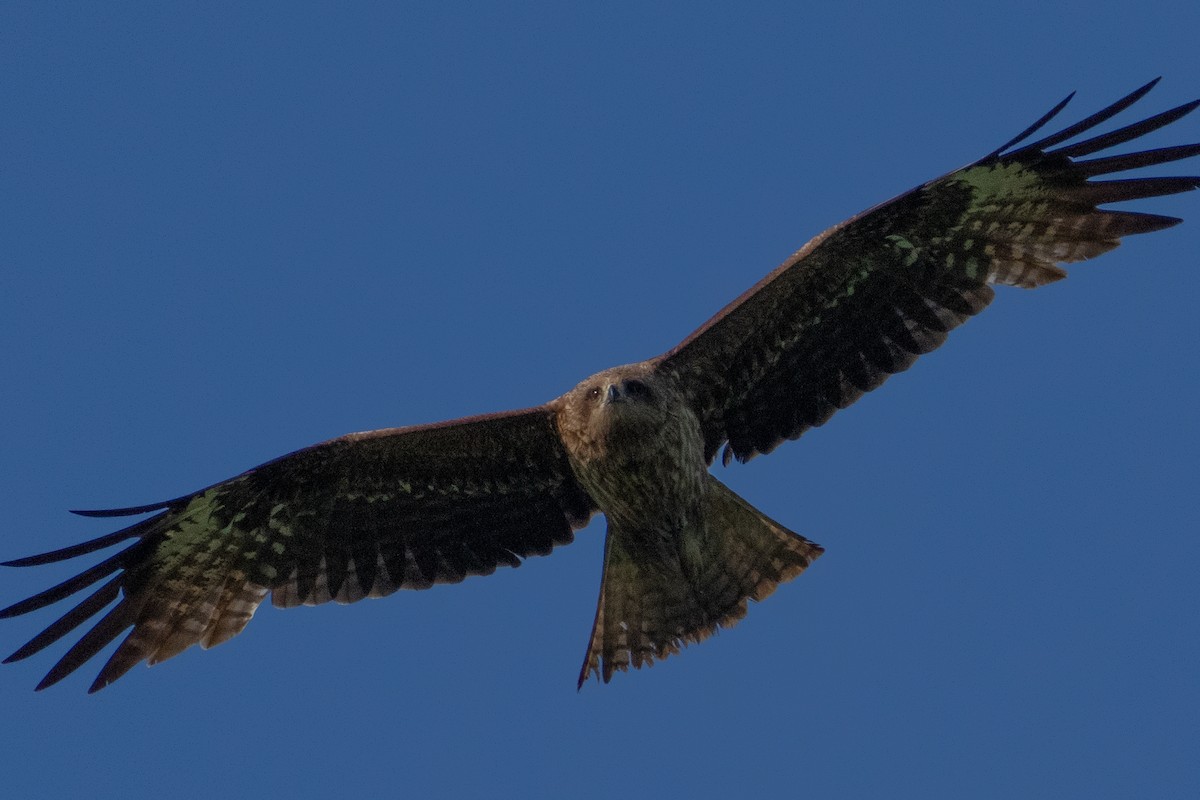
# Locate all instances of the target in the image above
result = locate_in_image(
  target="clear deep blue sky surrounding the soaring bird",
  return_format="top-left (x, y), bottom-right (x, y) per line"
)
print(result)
top-left (0, 1), bottom-right (1200, 800)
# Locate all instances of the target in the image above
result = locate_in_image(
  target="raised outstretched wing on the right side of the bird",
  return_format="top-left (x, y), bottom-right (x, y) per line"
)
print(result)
top-left (659, 80), bottom-right (1200, 463)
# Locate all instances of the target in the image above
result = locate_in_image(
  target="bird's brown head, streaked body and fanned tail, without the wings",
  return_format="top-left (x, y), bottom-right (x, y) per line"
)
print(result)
top-left (548, 360), bottom-right (821, 684)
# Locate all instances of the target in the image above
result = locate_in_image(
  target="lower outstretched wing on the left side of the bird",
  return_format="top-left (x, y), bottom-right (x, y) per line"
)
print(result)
top-left (0, 408), bottom-right (595, 691)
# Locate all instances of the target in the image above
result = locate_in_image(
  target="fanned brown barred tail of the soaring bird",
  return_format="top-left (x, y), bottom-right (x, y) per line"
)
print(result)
top-left (578, 475), bottom-right (824, 687)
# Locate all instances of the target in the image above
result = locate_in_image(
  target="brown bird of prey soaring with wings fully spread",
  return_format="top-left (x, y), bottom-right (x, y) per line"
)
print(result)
top-left (0, 82), bottom-right (1200, 691)
